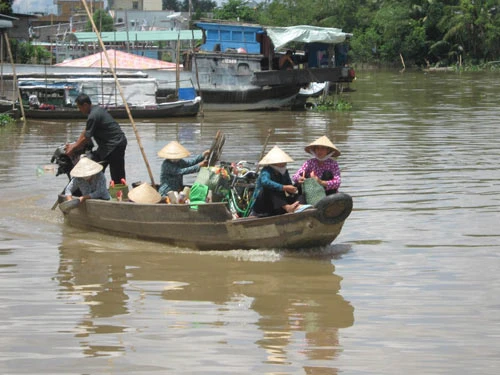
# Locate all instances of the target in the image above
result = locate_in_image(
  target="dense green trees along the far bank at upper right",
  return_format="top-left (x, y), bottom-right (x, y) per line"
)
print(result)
top-left (209, 0), bottom-right (500, 65)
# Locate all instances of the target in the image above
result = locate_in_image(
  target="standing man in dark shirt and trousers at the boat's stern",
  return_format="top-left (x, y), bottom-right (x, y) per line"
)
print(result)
top-left (66, 94), bottom-right (127, 184)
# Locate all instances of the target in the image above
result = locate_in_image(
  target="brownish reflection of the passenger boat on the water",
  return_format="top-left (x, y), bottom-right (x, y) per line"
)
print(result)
top-left (57, 228), bottom-right (354, 374)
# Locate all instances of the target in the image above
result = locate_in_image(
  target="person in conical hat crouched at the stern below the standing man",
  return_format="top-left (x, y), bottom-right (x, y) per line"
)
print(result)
top-left (64, 156), bottom-right (111, 202)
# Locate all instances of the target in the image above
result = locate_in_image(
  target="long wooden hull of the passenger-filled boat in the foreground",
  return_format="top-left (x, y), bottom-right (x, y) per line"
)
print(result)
top-left (59, 193), bottom-right (352, 250)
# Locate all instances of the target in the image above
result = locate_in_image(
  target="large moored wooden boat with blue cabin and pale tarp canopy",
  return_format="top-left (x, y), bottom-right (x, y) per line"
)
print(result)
top-left (154, 21), bottom-right (355, 111)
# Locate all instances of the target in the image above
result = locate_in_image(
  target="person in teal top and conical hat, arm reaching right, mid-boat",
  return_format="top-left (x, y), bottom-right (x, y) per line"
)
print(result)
top-left (158, 141), bottom-right (210, 197)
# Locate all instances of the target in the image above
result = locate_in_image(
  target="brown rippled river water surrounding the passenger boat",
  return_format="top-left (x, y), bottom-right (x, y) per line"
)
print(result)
top-left (0, 72), bottom-right (500, 375)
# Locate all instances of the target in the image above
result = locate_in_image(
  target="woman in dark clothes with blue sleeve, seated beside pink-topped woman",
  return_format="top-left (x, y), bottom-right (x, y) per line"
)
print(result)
top-left (250, 146), bottom-right (306, 217)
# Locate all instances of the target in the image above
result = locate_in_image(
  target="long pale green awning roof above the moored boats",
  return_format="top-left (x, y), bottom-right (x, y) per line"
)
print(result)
top-left (72, 30), bottom-right (202, 43)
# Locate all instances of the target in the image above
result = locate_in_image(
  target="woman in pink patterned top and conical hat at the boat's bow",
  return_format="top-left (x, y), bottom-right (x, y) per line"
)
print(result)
top-left (292, 136), bottom-right (341, 201)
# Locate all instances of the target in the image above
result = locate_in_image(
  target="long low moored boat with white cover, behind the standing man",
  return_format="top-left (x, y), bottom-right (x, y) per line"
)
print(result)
top-left (19, 77), bottom-right (201, 120)
